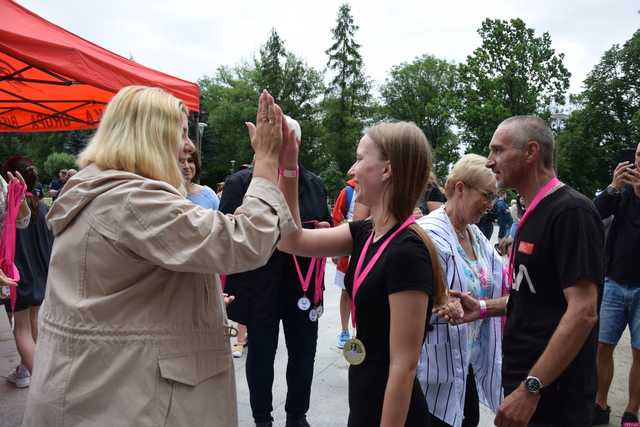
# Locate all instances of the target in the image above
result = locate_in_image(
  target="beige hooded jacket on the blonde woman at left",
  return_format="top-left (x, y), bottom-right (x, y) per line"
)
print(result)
top-left (23, 166), bottom-right (296, 427)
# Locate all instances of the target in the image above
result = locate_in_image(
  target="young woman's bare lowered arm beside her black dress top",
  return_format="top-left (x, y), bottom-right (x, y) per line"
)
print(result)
top-left (380, 290), bottom-right (429, 427)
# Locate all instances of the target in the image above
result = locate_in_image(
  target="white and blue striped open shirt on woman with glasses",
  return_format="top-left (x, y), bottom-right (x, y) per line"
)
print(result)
top-left (417, 207), bottom-right (503, 427)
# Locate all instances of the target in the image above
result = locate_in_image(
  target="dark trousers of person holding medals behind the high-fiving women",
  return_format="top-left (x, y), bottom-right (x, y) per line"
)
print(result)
top-left (246, 299), bottom-right (318, 423)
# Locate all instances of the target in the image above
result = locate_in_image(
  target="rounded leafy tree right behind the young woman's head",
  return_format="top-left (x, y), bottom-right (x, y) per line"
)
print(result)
top-left (381, 55), bottom-right (459, 178)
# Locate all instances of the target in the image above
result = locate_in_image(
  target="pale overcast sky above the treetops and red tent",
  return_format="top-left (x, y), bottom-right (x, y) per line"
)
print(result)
top-left (18, 0), bottom-right (640, 93)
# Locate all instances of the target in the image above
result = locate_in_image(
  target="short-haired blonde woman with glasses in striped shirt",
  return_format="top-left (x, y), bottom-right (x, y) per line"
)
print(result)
top-left (418, 154), bottom-right (503, 427)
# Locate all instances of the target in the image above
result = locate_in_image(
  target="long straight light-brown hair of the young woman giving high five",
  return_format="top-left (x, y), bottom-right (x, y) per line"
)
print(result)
top-left (366, 122), bottom-right (447, 306)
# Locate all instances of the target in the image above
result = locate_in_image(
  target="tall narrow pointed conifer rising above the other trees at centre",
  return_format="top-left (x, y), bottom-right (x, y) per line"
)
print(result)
top-left (322, 3), bottom-right (371, 172)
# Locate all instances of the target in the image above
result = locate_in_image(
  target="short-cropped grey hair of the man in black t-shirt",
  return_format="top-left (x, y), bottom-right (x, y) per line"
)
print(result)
top-left (498, 116), bottom-right (555, 168)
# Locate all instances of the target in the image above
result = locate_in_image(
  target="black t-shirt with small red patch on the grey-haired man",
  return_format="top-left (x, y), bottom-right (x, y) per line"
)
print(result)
top-left (502, 185), bottom-right (604, 422)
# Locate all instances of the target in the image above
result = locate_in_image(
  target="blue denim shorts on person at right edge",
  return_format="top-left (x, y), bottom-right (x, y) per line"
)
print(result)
top-left (598, 277), bottom-right (640, 349)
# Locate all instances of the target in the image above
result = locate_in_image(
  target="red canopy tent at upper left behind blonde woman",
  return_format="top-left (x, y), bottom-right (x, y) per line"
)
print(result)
top-left (0, 0), bottom-right (200, 132)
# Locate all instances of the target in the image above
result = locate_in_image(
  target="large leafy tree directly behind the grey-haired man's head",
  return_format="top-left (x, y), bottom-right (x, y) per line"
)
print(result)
top-left (458, 19), bottom-right (571, 154)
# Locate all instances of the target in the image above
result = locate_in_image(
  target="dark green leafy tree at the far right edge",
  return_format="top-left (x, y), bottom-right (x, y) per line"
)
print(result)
top-left (558, 30), bottom-right (640, 196)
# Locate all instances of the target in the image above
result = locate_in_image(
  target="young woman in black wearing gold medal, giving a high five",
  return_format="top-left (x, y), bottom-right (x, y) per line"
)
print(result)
top-left (279, 122), bottom-right (447, 427)
